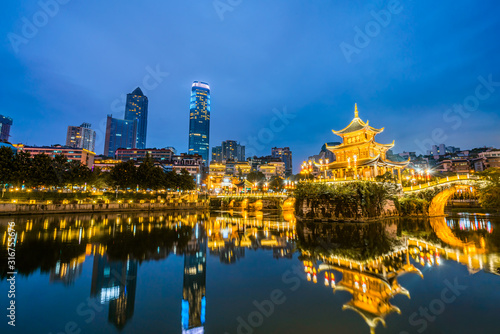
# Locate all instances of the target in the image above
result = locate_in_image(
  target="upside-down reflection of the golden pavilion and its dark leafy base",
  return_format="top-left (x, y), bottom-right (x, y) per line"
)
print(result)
top-left (297, 221), bottom-right (423, 333)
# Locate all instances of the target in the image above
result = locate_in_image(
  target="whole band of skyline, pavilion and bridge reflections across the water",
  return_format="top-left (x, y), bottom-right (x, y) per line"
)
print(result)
top-left (0, 212), bottom-right (500, 334)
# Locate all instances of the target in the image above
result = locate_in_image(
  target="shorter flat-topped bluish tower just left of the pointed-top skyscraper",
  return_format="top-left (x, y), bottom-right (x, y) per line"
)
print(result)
top-left (104, 115), bottom-right (137, 157)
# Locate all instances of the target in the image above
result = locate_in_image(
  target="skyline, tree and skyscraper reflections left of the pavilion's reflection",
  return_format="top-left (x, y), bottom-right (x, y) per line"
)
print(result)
top-left (0, 212), bottom-right (295, 334)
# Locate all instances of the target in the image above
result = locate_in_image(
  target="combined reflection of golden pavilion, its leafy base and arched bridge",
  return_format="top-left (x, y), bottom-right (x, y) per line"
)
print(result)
top-left (297, 217), bottom-right (500, 333)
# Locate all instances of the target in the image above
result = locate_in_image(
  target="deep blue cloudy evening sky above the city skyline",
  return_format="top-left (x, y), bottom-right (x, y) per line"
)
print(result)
top-left (0, 0), bottom-right (500, 171)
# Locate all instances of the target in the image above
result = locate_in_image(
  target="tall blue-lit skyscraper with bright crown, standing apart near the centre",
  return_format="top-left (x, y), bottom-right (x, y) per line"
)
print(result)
top-left (189, 81), bottom-right (210, 165)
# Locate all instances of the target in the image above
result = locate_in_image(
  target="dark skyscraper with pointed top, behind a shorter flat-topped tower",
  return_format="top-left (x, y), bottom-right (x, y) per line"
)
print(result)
top-left (125, 87), bottom-right (148, 149)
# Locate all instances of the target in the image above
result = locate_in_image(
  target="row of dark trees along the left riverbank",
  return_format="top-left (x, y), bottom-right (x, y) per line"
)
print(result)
top-left (0, 147), bottom-right (196, 190)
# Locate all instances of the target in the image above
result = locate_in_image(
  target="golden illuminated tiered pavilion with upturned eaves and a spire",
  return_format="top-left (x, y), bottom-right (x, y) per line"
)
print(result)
top-left (322, 105), bottom-right (409, 182)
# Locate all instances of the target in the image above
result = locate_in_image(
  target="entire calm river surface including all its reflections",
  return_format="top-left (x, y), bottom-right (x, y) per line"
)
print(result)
top-left (0, 212), bottom-right (500, 334)
